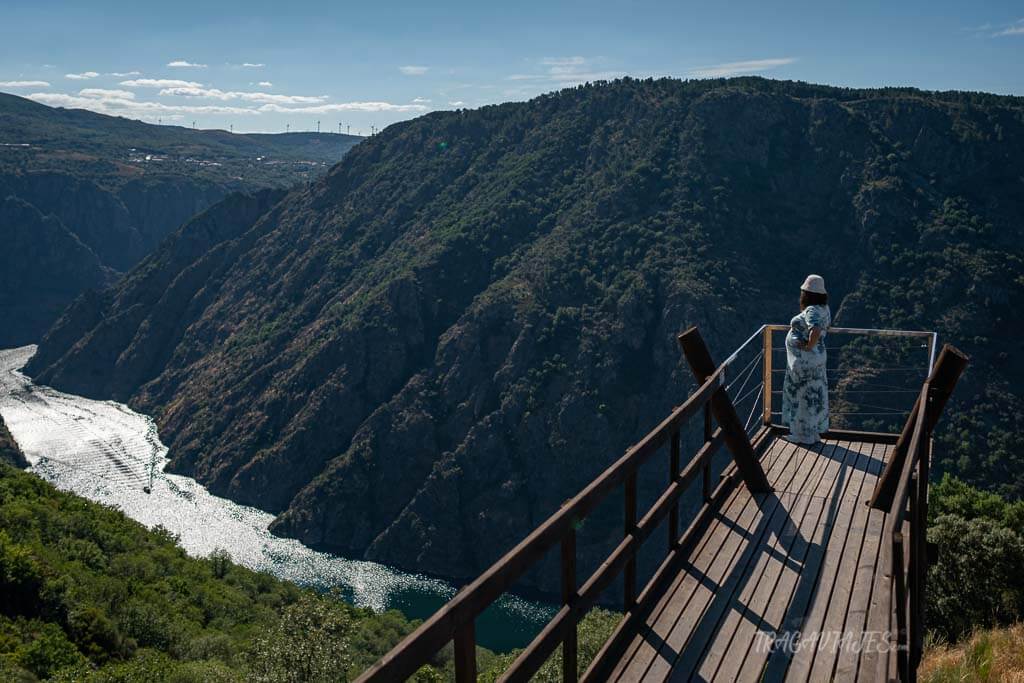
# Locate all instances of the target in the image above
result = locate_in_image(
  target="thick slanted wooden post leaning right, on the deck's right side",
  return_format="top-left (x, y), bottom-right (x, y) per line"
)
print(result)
top-left (868, 344), bottom-right (969, 512)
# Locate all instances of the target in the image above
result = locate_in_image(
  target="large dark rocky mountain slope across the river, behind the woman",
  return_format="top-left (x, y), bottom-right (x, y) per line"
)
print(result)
top-left (29, 79), bottom-right (1024, 588)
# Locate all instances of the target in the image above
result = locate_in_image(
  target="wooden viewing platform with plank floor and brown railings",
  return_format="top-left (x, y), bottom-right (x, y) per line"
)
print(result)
top-left (358, 326), bottom-right (967, 683)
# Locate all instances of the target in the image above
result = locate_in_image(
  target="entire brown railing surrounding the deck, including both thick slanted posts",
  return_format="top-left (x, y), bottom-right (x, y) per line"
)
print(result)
top-left (357, 325), bottom-right (967, 683)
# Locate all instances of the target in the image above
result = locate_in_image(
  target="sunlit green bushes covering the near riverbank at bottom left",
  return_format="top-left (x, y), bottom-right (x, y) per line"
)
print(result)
top-left (0, 464), bottom-right (425, 683)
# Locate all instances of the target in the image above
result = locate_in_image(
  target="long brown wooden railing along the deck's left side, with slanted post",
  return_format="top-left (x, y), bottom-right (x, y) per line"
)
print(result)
top-left (357, 328), bottom-right (769, 683)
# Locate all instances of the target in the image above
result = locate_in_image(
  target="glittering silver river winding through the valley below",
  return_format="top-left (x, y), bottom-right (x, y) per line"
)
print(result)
top-left (0, 346), bottom-right (554, 651)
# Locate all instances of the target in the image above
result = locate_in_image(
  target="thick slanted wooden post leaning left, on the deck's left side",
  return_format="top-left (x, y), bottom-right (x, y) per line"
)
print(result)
top-left (679, 328), bottom-right (771, 493)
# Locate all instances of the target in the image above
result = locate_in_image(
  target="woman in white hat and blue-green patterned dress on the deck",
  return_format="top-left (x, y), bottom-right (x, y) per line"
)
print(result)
top-left (782, 275), bottom-right (831, 443)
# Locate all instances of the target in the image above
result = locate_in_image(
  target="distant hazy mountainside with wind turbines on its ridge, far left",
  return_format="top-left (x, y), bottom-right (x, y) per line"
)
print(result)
top-left (0, 93), bottom-right (359, 346)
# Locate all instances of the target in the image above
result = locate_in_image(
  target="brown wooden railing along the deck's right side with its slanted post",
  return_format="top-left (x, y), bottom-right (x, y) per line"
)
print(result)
top-left (865, 344), bottom-right (968, 681)
